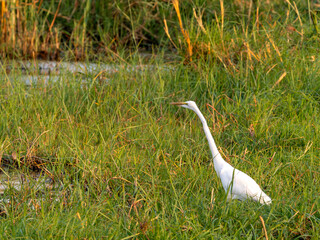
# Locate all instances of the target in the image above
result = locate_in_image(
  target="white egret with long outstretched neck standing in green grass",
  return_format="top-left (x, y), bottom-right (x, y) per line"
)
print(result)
top-left (171, 101), bottom-right (271, 204)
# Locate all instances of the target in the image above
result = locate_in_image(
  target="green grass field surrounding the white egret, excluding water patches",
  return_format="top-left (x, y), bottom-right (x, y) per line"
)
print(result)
top-left (0, 1), bottom-right (320, 239)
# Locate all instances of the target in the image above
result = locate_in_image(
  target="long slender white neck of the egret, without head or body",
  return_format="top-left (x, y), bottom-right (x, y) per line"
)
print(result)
top-left (192, 108), bottom-right (228, 172)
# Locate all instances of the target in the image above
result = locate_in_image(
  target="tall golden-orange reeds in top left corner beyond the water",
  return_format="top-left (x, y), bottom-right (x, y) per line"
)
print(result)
top-left (0, 0), bottom-right (61, 58)
